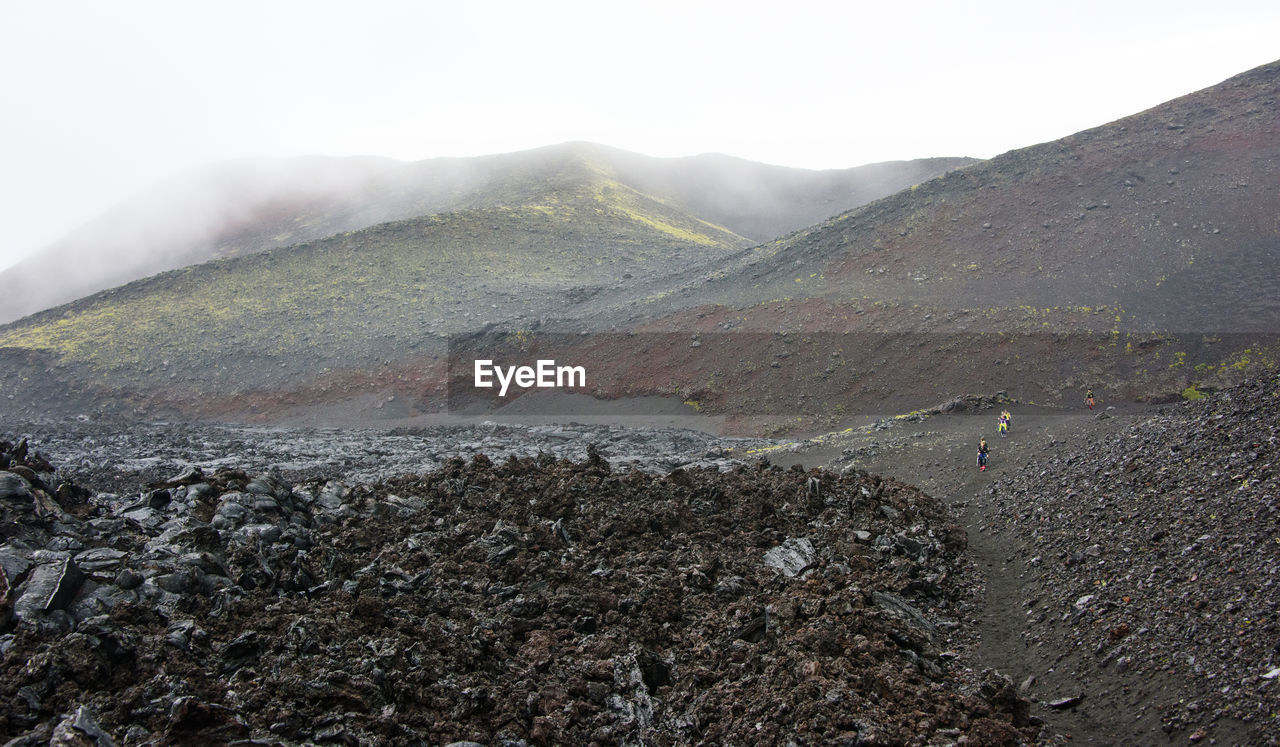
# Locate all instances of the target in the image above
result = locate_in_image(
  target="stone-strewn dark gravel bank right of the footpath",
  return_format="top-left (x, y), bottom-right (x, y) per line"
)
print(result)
top-left (974, 380), bottom-right (1280, 743)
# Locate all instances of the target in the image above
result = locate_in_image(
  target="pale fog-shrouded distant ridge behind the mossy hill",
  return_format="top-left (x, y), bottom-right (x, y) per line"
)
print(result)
top-left (0, 143), bottom-right (969, 321)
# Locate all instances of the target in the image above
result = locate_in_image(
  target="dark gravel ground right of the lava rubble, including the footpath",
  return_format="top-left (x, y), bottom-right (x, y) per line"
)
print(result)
top-left (768, 374), bottom-right (1280, 744)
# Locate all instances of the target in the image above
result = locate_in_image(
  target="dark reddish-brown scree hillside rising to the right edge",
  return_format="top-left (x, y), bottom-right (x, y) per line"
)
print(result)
top-left (481, 63), bottom-right (1280, 429)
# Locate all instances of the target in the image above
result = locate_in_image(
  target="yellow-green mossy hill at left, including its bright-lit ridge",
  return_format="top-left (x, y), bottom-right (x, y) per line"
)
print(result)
top-left (0, 155), bottom-right (768, 412)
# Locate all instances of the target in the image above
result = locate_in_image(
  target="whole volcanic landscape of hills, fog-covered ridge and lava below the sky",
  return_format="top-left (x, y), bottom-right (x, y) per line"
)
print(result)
top-left (0, 63), bottom-right (1280, 746)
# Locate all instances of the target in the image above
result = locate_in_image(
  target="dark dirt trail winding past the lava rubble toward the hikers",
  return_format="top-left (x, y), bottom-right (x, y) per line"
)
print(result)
top-left (773, 407), bottom-right (1165, 744)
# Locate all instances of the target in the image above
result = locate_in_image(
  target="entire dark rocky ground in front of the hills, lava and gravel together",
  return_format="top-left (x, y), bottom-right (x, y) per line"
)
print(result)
top-left (0, 377), bottom-right (1280, 744)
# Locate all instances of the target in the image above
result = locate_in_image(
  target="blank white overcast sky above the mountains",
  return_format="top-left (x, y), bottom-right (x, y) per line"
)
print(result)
top-left (0, 0), bottom-right (1280, 267)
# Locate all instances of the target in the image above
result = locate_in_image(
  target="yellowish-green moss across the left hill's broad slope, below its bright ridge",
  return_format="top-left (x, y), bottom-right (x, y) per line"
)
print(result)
top-left (0, 196), bottom-right (731, 376)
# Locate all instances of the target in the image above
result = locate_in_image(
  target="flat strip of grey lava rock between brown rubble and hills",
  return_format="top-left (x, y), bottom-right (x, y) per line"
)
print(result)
top-left (2, 421), bottom-right (772, 492)
